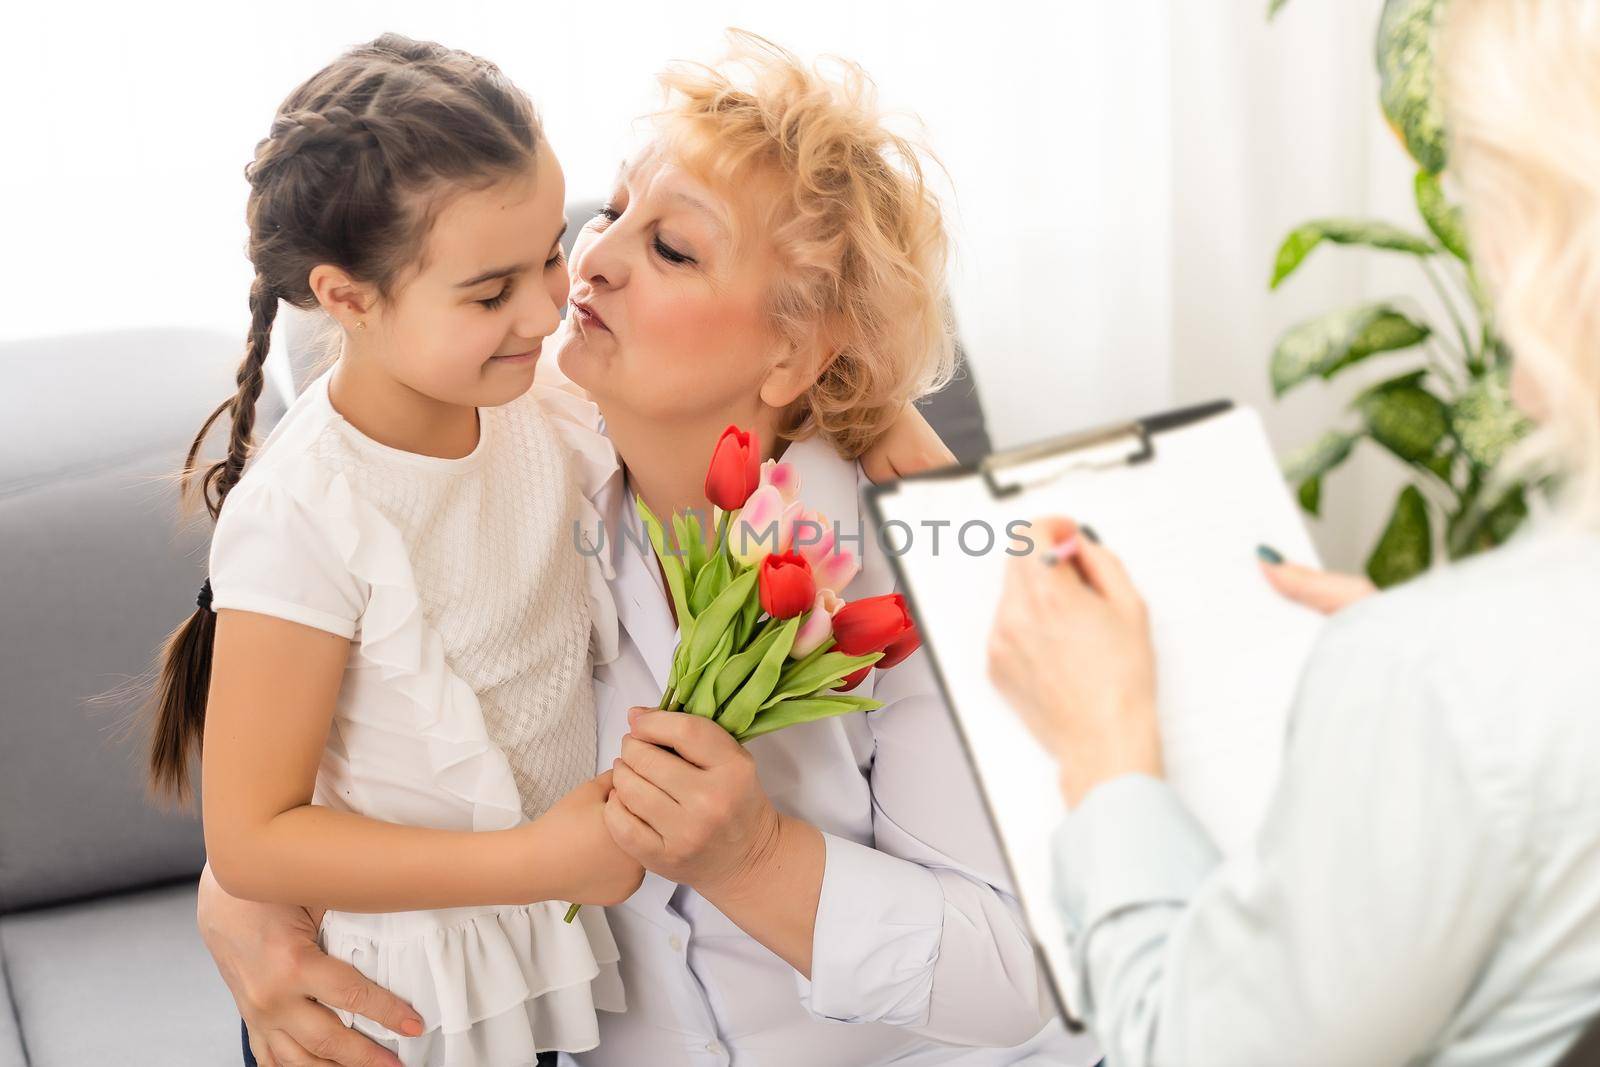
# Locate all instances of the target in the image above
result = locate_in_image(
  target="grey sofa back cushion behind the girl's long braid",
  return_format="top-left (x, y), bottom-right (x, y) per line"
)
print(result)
top-left (0, 331), bottom-right (240, 912)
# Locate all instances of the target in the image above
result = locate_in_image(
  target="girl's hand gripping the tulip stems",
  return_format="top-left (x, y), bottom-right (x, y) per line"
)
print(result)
top-left (530, 771), bottom-right (645, 905)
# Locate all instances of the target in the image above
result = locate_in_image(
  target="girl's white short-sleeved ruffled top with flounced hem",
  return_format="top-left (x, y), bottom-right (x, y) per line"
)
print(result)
top-left (201, 371), bottom-right (624, 1067)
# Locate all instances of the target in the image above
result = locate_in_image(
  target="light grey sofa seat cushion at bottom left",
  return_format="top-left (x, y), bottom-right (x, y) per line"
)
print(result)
top-left (0, 883), bottom-right (240, 1067)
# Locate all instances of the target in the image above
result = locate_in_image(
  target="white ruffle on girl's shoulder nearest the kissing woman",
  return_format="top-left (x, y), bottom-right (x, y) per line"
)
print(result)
top-left (530, 384), bottom-right (621, 664)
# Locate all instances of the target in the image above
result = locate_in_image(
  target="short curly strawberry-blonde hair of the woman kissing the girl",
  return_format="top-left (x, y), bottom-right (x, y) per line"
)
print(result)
top-left (654, 30), bottom-right (955, 459)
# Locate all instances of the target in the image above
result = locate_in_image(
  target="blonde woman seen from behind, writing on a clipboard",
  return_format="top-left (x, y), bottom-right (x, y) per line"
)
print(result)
top-left (990, 0), bottom-right (1600, 1067)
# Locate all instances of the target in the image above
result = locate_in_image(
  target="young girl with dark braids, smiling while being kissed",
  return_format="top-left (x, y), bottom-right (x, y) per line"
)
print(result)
top-left (150, 35), bottom-right (947, 1067)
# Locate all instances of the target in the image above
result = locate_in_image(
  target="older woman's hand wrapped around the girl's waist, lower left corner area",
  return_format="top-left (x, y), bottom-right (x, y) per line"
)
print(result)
top-left (195, 867), bottom-right (422, 1067)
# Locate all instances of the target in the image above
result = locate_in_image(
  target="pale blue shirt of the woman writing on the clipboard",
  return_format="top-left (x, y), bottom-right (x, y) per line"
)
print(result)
top-left (1056, 531), bottom-right (1600, 1067)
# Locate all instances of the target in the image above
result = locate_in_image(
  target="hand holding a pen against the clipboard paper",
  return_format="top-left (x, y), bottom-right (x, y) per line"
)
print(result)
top-left (989, 518), bottom-right (1162, 805)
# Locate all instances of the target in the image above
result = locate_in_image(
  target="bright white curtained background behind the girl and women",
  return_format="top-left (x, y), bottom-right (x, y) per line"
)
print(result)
top-left (0, 0), bottom-right (1427, 563)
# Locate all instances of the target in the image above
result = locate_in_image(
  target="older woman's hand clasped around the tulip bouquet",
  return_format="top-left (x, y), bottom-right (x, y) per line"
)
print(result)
top-left (605, 707), bottom-right (779, 899)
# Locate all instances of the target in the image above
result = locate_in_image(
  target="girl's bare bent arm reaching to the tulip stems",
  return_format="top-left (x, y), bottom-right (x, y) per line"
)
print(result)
top-left (202, 609), bottom-right (643, 912)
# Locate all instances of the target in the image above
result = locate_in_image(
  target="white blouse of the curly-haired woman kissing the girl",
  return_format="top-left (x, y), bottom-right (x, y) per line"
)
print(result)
top-left (576, 438), bottom-right (1098, 1067)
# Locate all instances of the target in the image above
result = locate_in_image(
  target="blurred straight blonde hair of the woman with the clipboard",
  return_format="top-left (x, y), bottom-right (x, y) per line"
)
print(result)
top-left (1440, 0), bottom-right (1600, 526)
